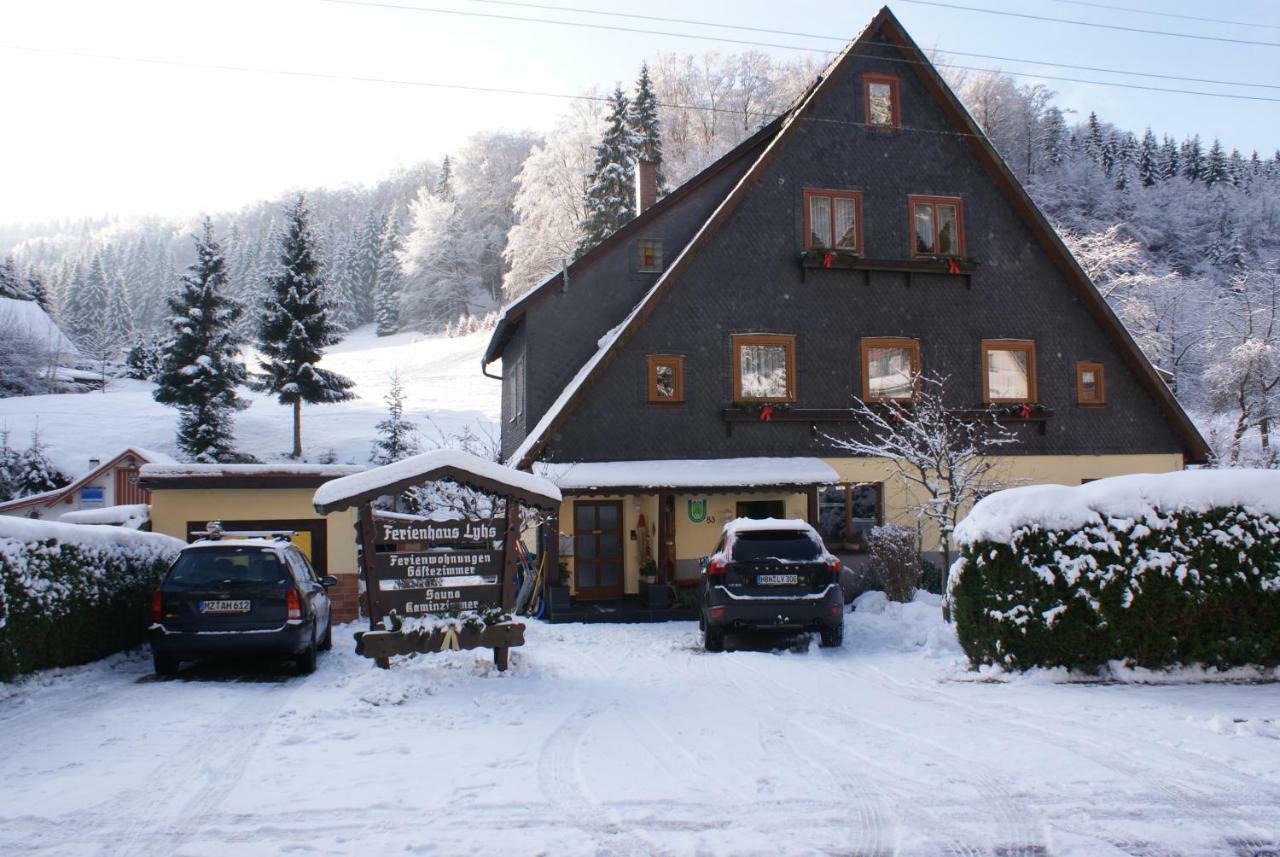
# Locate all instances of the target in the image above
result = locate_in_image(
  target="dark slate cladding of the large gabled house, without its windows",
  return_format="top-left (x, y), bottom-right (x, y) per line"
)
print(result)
top-left (486, 13), bottom-right (1188, 470)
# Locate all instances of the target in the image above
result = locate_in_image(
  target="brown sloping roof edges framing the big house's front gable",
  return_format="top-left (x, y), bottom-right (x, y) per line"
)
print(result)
top-left (495, 6), bottom-right (1210, 467)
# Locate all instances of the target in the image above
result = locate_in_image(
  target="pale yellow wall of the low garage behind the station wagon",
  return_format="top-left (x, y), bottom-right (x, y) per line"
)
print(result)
top-left (151, 487), bottom-right (357, 574)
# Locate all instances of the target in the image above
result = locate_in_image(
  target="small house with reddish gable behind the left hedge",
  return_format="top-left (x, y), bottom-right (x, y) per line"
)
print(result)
top-left (0, 446), bottom-right (173, 523)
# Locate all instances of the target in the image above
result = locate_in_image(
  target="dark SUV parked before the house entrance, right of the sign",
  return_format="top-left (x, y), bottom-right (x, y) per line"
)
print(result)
top-left (701, 518), bottom-right (845, 651)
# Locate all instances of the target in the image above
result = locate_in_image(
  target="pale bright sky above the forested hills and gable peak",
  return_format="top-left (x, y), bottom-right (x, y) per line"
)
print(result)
top-left (0, 0), bottom-right (1280, 223)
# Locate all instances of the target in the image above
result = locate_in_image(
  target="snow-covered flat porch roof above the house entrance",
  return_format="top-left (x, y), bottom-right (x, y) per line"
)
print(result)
top-left (534, 458), bottom-right (840, 491)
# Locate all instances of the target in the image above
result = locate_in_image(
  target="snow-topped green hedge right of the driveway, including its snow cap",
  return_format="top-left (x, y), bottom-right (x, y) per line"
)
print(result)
top-left (950, 471), bottom-right (1280, 672)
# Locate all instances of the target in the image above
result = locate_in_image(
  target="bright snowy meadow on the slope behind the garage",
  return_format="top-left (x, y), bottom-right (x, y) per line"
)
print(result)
top-left (0, 325), bottom-right (502, 477)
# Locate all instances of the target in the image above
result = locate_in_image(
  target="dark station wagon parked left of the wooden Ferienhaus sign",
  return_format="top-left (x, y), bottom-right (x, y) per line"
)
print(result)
top-left (147, 539), bottom-right (338, 675)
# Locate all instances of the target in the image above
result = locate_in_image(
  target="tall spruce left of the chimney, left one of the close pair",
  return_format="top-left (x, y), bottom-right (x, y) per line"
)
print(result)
top-left (577, 86), bottom-right (636, 256)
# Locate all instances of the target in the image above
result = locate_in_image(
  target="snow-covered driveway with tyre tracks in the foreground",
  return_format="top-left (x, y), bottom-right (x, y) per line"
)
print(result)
top-left (0, 595), bottom-right (1280, 857)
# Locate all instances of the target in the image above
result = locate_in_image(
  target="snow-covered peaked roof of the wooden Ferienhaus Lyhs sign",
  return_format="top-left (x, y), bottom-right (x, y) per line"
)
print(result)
top-left (312, 449), bottom-right (561, 514)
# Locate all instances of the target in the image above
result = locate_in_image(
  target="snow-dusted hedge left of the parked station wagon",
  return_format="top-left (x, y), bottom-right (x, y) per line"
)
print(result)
top-left (0, 515), bottom-right (182, 680)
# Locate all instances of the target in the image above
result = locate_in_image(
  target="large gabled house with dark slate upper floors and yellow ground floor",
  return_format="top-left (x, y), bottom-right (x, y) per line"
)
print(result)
top-left (484, 9), bottom-right (1208, 611)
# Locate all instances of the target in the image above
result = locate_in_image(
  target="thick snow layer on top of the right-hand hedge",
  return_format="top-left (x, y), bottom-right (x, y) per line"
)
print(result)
top-left (955, 469), bottom-right (1280, 545)
